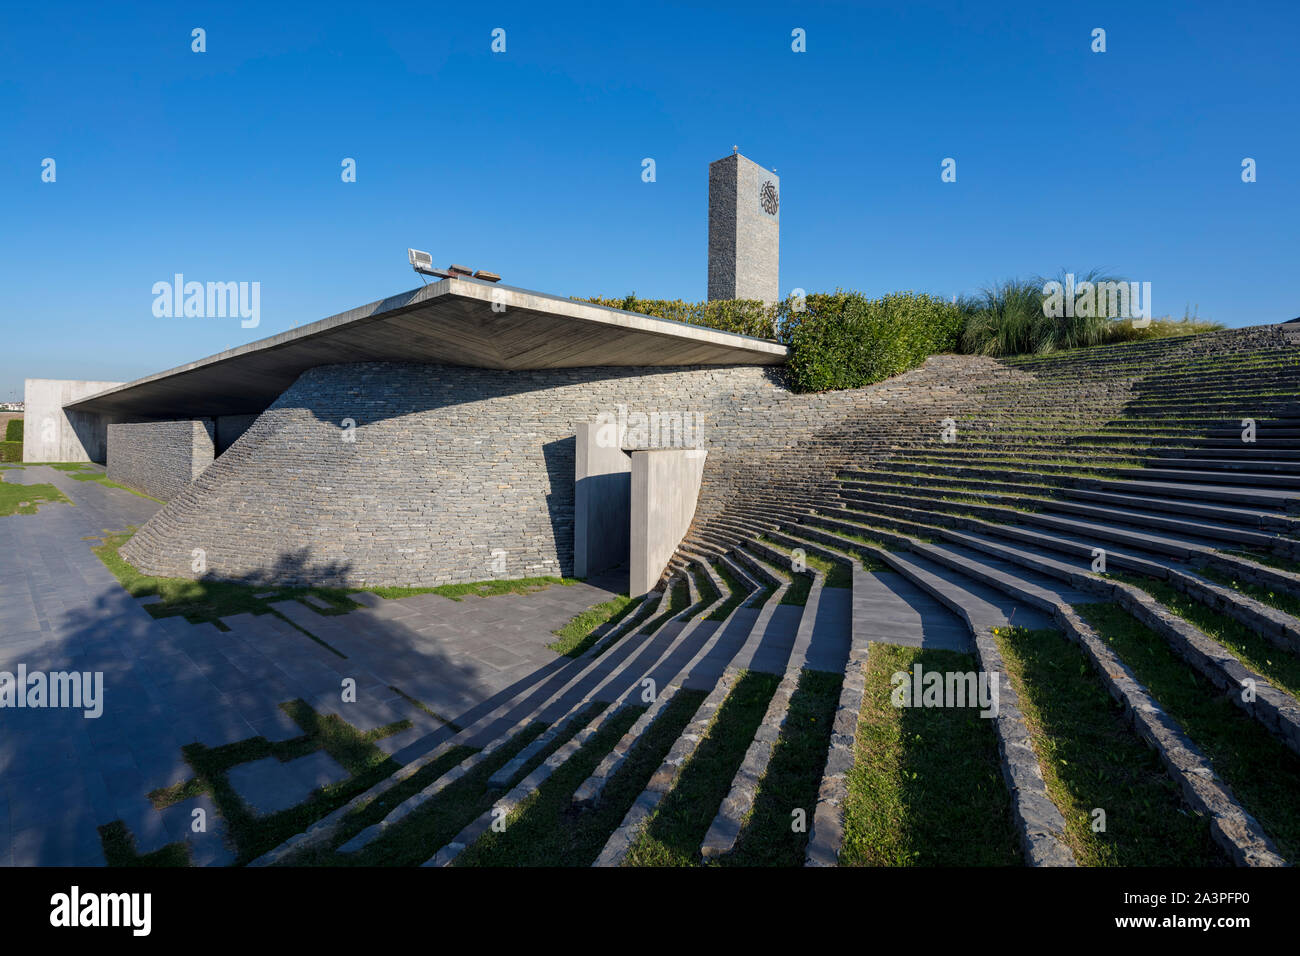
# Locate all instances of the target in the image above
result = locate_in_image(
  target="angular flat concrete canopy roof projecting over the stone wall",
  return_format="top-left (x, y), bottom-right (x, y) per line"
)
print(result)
top-left (64, 278), bottom-right (787, 418)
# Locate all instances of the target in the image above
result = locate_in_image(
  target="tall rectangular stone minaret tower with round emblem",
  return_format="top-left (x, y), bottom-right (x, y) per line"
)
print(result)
top-left (709, 152), bottom-right (781, 302)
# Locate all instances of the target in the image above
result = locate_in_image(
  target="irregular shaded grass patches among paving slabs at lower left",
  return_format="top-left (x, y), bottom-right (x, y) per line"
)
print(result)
top-left (109, 700), bottom-right (411, 865)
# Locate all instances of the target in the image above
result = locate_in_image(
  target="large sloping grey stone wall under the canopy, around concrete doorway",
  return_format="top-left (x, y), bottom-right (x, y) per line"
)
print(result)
top-left (122, 363), bottom-right (967, 585)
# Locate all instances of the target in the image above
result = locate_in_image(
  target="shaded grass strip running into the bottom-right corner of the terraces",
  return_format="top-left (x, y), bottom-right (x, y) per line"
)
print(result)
top-left (1075, 604), bottom-right (1300, 860)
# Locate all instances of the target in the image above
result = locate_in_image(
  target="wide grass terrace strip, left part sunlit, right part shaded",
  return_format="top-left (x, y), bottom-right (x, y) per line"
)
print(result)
top-left (840, 644), bottom-right (1021, 866)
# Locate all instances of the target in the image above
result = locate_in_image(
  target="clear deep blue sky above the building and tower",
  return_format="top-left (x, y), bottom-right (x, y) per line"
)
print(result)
top-left (0, 0), bottom-right (1300, 399)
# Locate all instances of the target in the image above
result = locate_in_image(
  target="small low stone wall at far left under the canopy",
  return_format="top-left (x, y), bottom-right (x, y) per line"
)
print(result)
top-left (108, 419), bottom-right (215, 501)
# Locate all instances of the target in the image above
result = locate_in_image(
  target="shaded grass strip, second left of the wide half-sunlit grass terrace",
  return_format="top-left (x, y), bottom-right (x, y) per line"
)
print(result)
top-left (624, 671), bottom-right (781, 866)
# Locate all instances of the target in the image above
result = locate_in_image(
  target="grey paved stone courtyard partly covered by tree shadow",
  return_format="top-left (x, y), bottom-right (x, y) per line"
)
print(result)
top-left (0, 467), bottom-right (618, 866)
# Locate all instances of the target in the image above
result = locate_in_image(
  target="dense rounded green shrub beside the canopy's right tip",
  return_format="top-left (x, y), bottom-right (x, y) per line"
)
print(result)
top-left (779, 291), bottom-right (965, 392)
